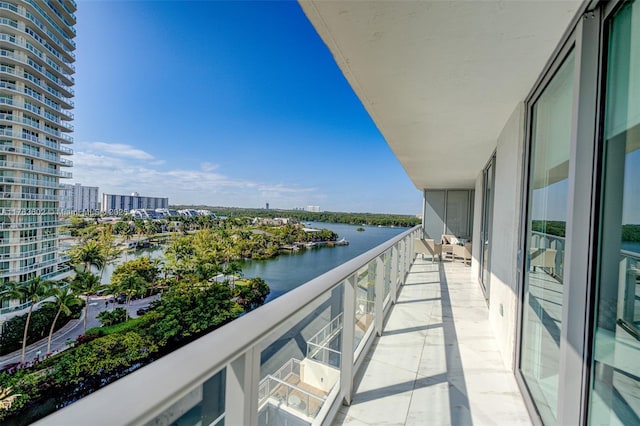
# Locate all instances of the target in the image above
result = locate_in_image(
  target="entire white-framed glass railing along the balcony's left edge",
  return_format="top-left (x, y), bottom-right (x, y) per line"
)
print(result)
top-left (44, 227), bottom-right (420, 425)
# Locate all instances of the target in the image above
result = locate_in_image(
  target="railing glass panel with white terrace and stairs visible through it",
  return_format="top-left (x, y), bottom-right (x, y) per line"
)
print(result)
top-left (258, 284), bottom-right (344, 425)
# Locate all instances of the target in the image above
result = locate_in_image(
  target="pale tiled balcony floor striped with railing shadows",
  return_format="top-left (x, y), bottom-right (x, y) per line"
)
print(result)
top-left (335, 258), bottom-right (531, 425)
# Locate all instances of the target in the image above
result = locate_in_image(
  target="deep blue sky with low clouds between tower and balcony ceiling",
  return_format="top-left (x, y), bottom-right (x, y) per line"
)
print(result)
top-left (72, 0), bottom-right (422, 214)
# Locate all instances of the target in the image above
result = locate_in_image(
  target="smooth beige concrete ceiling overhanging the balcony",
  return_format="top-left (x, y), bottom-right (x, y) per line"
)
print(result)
top-left (300, 0), bottom-right (581, 189)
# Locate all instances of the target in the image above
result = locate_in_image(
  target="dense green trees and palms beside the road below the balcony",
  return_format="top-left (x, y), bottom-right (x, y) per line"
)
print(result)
top-left (0, 225), bottom-right (270, 421)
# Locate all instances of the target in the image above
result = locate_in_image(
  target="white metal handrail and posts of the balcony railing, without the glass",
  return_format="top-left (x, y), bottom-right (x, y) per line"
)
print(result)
top-left (40, 227), bottom-right (421, 426)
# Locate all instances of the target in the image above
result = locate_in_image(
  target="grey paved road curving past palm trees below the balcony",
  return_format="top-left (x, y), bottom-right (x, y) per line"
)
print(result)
top-left (0, 295), bottom-right (158, 368)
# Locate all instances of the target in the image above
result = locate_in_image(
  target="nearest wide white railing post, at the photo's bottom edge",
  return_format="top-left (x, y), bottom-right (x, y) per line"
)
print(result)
top-left (225, 345), bottom-right (260, 426)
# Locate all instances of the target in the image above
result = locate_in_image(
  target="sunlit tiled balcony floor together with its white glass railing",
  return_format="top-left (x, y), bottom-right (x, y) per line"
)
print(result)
top-left (43, 228), bottom-right (530, 425)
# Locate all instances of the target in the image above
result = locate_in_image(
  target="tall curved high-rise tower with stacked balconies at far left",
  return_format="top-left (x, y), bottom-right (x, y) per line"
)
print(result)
top-left (0, 0), bottom-right (76, 288)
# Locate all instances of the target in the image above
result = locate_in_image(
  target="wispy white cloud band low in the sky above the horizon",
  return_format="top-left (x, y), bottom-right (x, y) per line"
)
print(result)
top-left (71, 142), bottom-right (317, 208)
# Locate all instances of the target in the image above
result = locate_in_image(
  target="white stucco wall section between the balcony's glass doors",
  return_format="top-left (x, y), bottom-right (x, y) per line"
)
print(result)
top-left (489, 103), bottom-right (525, 369)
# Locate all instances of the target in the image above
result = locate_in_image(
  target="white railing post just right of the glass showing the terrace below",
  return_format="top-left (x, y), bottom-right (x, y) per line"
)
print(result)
top-left (340, 274), bottom-right (356, 406)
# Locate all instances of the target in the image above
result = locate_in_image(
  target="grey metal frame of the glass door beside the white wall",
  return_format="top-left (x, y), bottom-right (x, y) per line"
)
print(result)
top-left (513, 1), bottom-right (611, 424)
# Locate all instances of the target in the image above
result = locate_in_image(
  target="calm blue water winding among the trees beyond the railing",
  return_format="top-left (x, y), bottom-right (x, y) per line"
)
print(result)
top-left (102, 222), bottom-right (408, 301)
